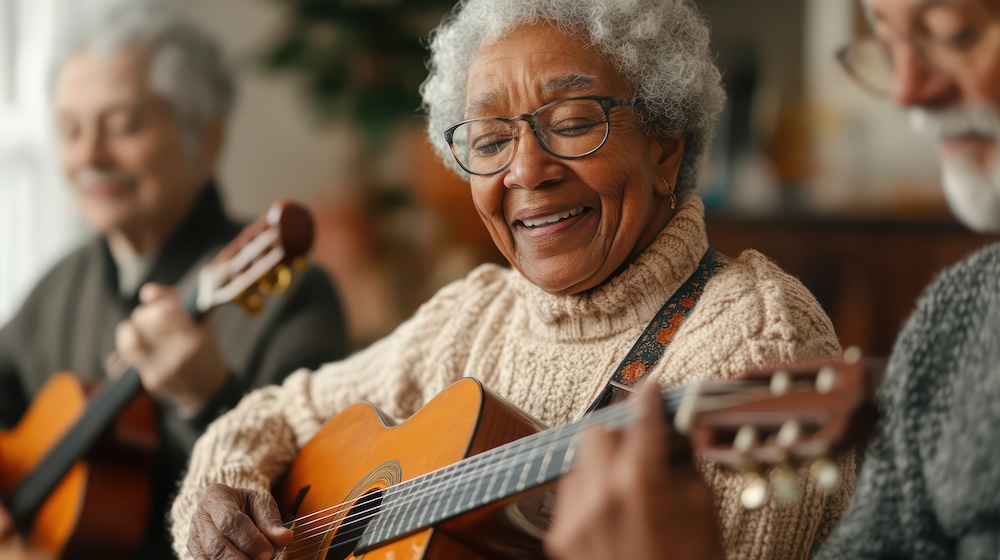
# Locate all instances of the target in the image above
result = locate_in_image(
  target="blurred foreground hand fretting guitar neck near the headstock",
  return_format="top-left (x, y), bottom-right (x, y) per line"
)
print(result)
top-left (545, 384), bottom-right (724, 560)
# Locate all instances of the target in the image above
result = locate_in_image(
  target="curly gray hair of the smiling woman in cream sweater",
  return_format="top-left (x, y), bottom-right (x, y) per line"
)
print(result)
top-left (421, 0), bottom-right (726, 197)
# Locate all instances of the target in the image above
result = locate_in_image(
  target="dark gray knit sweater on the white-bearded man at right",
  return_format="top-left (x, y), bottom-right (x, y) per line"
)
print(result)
top-left (819, 244), bottom-right (1000, 560)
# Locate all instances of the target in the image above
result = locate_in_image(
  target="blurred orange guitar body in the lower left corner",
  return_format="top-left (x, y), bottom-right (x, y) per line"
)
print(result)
top-left (0, 373), bottom-right (158, 558)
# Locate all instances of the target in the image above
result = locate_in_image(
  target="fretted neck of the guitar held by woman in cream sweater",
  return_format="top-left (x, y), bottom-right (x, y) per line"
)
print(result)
top-left (357, 388), bottom-right (685, 551)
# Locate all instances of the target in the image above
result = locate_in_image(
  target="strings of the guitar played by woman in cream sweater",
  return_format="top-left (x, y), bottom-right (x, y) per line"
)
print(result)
top-left (274, 381), bottom-right (764, 552)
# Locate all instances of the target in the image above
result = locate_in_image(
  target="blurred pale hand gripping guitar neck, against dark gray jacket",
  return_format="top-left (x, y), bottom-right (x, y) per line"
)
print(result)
top-left (115, 284), bottom-right (229, 416)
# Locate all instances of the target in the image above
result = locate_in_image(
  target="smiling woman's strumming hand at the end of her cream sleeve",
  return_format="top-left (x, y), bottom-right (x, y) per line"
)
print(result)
top-left (187, 484), bottom-right (292, 560)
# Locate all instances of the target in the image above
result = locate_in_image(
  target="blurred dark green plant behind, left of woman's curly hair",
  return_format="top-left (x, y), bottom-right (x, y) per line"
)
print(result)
top-left (263, 0), bottom-right (454, 146)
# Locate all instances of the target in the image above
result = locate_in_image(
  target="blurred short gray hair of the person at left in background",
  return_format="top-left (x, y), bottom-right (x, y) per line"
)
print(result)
top-left (51, 0), bottom-right (236, 154)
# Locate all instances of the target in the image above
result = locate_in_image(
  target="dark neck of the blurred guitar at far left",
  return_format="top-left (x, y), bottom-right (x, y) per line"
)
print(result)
top-left (3, 289), bottom-right (206, 534)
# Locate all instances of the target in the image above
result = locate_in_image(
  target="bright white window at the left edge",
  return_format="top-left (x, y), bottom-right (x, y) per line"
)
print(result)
top-left (0, 0), bottom-right (81, 323)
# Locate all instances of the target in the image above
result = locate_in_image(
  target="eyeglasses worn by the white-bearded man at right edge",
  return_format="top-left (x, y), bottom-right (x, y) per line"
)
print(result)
top-left (837, 0), bottom-right (1000, 96)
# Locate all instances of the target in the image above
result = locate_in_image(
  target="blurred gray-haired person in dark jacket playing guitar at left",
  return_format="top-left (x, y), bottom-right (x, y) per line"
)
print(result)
top-left (0, 0), bottom-right (346, 558)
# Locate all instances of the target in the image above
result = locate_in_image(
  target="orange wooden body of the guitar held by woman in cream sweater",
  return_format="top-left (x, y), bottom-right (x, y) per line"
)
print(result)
top-left (274, 378), bottom-right (544, 560)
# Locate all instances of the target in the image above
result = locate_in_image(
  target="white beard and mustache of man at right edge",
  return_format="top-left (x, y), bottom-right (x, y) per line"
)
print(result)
top-left (910, 107), bottom-right (1000, 233)
